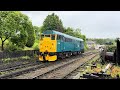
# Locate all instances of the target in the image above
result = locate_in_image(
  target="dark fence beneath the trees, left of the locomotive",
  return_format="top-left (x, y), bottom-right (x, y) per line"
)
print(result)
top-left (0, 50), bottom-right (39, 60)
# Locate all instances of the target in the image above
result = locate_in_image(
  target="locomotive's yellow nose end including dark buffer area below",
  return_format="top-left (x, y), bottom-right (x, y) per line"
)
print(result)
top-left (39, 37), bottom-right (57, 61)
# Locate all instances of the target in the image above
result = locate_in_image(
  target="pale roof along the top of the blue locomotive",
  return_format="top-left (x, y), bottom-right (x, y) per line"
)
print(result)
top-left (43, 30), bottom-right (83, 41)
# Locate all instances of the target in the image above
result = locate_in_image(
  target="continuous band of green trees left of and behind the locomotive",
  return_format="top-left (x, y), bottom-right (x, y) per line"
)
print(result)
top-left (0, 11), bottom-right (87, 51)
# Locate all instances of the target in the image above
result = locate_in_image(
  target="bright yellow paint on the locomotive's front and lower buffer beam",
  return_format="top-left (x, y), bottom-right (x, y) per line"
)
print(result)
top-left (39, 37), bottom-right (57, 61)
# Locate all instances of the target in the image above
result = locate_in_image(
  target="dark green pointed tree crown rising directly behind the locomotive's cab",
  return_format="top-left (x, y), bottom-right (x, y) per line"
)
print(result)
top-left (41, 13), bottom-right (64, 32)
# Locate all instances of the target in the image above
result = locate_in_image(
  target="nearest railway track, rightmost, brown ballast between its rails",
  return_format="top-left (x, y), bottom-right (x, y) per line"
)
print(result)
top-left (32, 55), bottom-right (96, 79)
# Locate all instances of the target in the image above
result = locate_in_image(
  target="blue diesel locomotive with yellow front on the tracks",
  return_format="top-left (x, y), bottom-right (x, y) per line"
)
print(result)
top-left (39, 30), bottom-right (84, 61)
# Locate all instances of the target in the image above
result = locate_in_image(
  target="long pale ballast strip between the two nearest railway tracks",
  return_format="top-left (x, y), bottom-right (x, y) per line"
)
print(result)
top-left (13, 53), bottom-right (97, 79)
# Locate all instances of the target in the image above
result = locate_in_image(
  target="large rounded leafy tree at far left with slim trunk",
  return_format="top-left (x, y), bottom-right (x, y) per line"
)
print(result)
top-left (0, 11), bottom-right (35, 50)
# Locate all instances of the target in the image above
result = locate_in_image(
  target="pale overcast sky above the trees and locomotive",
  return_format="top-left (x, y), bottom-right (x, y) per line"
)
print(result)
top-left (22, 11), bottom-right (120, 38)
